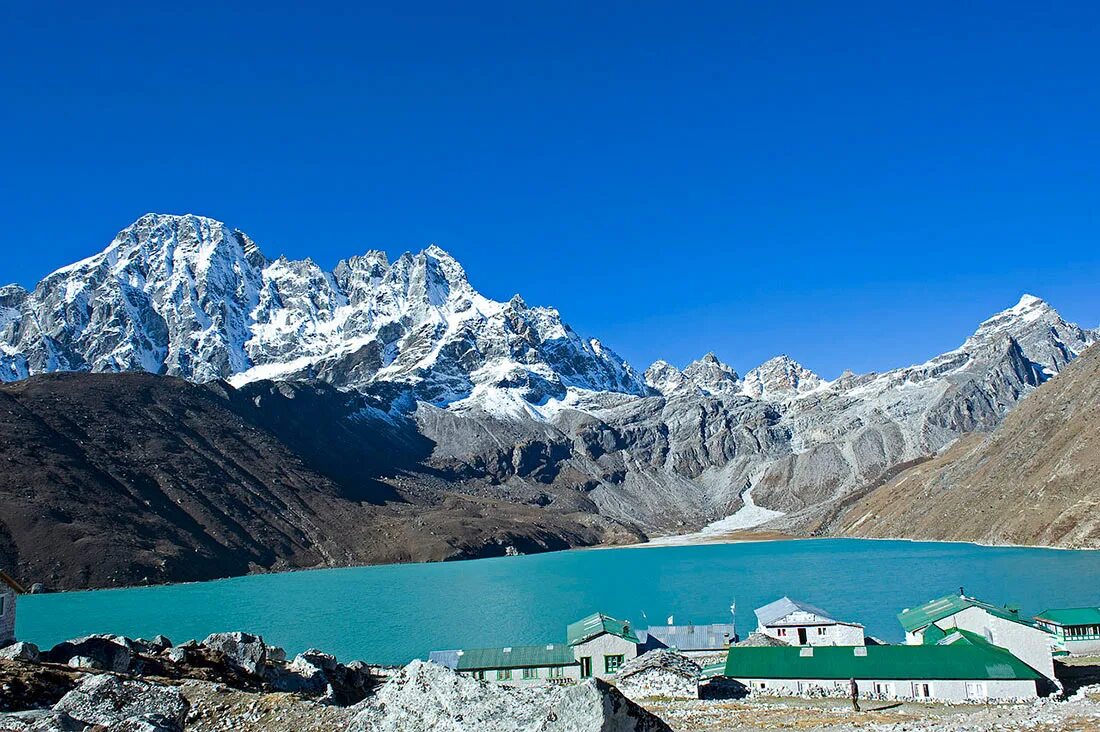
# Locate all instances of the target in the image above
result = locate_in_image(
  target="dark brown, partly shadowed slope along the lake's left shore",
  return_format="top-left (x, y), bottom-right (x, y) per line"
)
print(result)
top-left (0, 373), bottom-right (634, 589)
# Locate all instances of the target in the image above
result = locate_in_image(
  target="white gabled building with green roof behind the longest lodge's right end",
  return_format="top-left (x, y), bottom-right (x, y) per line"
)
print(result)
top-left (898, 594), bottom-right (1057, 681)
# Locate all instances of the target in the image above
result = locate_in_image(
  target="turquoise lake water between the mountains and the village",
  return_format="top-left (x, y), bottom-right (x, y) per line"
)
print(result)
top-left (18, 539), bottom-right (1100, 664)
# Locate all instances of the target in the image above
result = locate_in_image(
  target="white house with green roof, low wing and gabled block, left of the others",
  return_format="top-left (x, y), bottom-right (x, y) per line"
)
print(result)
top-left (428, 613), bottom-right (640, 686)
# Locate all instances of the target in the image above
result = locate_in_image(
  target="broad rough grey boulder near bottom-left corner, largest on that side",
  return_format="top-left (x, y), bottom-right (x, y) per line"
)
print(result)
top-left (54, 674), bottom-right (190, 732)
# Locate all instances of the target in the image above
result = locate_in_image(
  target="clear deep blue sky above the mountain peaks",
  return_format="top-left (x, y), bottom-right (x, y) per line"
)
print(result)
top-left (0, 0), bottom-right (1100, 376)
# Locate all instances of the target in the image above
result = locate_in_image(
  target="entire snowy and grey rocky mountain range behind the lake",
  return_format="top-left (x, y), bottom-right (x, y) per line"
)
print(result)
top-left (0, 215), bottom-right (1100, 582)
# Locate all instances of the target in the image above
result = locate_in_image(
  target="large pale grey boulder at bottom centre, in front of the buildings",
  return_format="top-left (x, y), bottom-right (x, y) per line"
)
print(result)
top-left (349, 660), bottom-right (671, 732)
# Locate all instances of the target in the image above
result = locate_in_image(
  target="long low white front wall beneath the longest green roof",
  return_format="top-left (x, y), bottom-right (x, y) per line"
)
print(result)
top-left (736, 678), bottom-right (1038, 701)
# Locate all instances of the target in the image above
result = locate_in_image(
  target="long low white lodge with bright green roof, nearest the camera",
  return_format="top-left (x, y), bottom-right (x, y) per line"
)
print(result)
top-left (724, 631), bottom-right (1044, 701)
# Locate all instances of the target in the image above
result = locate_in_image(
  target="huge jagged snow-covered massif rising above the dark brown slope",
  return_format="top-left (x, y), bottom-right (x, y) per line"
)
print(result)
top-left (0, 214), bottom-right (648, 405)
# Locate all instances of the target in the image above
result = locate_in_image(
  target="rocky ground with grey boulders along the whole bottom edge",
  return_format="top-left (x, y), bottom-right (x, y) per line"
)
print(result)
top-left (0, 633), bottom-right (1100, 732)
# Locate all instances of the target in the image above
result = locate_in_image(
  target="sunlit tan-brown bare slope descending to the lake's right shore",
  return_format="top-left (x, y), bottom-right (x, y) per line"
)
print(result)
top-left (818, 347), bottom-right (1100, 541)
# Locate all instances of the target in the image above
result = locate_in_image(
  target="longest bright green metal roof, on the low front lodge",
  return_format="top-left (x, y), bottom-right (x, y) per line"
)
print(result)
top-left (725, 643), bottom-right (1042, 680)
